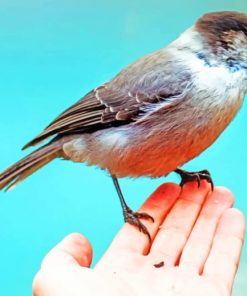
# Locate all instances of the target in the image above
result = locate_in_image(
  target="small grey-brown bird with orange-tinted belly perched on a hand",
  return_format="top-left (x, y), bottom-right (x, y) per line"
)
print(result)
top-left (0, 11), bottom-right (247, 238)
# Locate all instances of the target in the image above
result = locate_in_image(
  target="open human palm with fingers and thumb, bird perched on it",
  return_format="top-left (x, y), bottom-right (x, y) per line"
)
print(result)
top-left (33, 182), bottom-right (245, 296)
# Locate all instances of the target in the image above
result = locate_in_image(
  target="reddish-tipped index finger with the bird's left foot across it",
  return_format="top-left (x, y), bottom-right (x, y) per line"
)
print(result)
top-left (109, 183), bottom-right (181, 254)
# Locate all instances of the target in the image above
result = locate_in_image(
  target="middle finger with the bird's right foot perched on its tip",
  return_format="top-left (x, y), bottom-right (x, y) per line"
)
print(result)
top-left (150, 181), bottom-right (210, 266)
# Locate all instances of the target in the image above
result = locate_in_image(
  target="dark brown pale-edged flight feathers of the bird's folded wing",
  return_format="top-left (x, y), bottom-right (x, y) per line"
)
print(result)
top-left (23, 85), bottom-right (168, 149)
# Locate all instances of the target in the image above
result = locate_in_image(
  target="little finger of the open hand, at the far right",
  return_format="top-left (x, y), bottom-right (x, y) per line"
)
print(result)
top-left (203, 209), bottom-right (245, 291)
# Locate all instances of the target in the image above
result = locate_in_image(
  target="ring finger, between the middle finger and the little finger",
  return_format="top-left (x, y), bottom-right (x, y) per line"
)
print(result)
top-left (179, 187), bottom-right (233, 273)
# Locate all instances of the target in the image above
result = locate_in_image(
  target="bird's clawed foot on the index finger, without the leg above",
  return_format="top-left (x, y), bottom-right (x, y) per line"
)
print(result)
top-left (123, 208), bottom-right (154, 242)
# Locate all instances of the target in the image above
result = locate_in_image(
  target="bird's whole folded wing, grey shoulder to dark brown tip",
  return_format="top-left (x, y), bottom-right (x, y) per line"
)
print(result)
top-left (23, 53), bottom-right (190, 149)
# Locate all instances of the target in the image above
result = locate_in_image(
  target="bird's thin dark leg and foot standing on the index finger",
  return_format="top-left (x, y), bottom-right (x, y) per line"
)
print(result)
top-left (112, 175), bottom-right (154, 241)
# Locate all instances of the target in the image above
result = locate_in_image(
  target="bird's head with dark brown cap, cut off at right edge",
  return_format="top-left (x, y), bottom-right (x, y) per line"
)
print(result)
top-left (195, 11), bottom-right (247, 71)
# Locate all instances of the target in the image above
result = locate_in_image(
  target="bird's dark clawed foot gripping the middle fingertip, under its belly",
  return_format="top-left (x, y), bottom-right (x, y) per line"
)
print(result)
top-left (174, 168), bottom-right (214, 191)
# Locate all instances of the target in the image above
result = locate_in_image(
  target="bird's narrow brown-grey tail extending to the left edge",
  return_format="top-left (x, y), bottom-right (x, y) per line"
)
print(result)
top-left (0, 141), bottom-right (61, 191)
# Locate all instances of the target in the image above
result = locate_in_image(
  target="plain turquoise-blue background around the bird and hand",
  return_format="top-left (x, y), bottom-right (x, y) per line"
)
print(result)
top-left (0, 0), bottom-right (247, 296)
